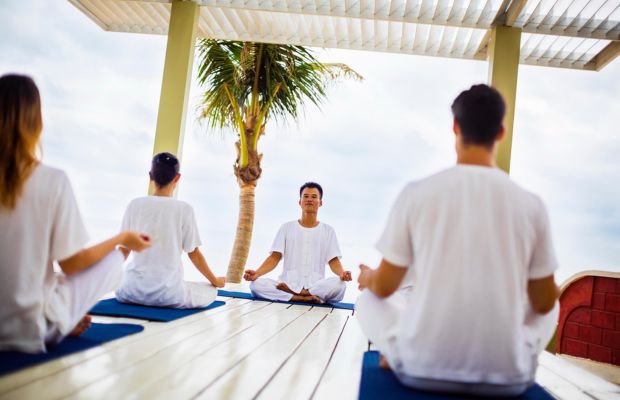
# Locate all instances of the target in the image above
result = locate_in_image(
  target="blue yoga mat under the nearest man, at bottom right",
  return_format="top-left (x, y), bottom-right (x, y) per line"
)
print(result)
top-left (359, 351), bottom-right (554, 400)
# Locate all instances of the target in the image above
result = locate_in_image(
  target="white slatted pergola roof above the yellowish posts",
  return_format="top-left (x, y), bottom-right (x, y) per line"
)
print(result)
top-left (69, 0), bottom-right (620, 70)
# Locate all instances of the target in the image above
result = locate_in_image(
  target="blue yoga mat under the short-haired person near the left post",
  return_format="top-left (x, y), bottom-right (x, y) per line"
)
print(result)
top-left (88, 299), bottom-right (226, 322)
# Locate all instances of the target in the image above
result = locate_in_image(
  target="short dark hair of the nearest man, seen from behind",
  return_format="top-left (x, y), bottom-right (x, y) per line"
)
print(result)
top-left (452, 85), bottom-right (506, 147)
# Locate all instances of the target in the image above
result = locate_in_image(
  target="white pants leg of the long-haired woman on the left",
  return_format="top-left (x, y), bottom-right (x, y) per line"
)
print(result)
top-left (45, 250), bottom-right (124, 344)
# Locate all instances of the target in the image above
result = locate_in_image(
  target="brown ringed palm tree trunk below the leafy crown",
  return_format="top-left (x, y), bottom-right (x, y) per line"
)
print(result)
top-left (226, 184), bottom-right (256, 283)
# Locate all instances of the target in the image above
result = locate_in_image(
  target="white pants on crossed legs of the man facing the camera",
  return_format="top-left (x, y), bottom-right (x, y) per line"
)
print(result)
top-left (250, 277), bottom-right (347, 303)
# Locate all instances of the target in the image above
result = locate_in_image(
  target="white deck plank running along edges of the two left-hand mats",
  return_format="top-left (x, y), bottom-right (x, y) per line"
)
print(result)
top-left (0, 299), bottom-right (249, 394)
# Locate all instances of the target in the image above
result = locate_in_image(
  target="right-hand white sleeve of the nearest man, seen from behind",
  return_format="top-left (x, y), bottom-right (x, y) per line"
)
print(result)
top-left (529, 200), bottom-right (558, 279)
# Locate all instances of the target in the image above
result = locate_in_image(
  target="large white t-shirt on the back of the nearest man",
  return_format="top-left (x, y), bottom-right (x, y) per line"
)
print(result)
top-left (377, 165), bottom-right (557, 384)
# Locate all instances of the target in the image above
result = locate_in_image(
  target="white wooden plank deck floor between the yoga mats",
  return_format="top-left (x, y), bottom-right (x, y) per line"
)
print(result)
top-left (0, 286), bottom-right (620, 400)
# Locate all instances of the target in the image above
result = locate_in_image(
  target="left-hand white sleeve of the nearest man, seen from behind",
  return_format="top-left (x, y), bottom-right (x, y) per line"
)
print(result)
top-left (376, 186), bottom-right (413, 268)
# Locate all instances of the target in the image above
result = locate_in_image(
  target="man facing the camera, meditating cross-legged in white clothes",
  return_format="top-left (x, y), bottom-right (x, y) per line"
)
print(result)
top-left (243, 182), bottom-right (351, 303)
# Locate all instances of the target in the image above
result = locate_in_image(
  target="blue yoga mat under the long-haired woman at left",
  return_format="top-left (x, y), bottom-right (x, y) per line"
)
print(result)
top-left (0, 323), bottom-right (144, 375)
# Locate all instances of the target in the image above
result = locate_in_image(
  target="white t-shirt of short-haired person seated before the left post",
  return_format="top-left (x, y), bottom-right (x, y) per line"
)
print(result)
top-left (116, 196), bottom-right (201, 307)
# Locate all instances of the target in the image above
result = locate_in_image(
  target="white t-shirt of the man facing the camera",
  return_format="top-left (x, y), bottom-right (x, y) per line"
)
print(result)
top-left (271, 221), bottom-right (342, 292)
